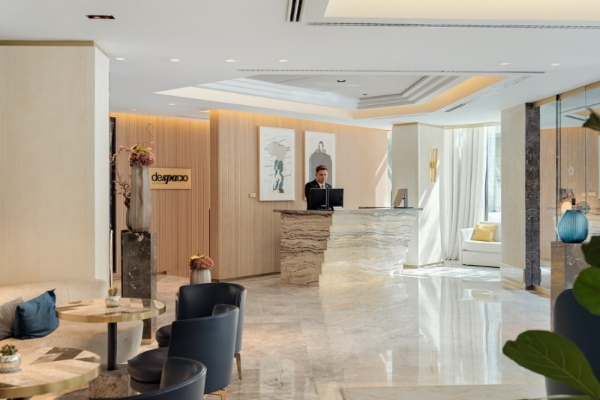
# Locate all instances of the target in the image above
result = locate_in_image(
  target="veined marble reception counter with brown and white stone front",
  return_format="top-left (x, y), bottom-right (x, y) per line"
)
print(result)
top-left (274, 208), bottom-right (421, 286)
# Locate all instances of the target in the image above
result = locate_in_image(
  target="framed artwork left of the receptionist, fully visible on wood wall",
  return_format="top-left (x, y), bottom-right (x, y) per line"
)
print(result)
top-left (258, 126), bottom-right (296, 201)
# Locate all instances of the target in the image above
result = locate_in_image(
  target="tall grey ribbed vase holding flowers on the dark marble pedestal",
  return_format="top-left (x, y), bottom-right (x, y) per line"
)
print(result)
top-left (127, 164), bottom-right (152, 232)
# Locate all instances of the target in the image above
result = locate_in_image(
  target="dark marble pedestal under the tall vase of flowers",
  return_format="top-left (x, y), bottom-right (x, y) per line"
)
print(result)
top-left (121, 231), bottom-right (157, 344)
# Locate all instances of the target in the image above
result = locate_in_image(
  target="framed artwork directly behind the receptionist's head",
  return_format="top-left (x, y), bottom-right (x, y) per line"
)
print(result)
top-left (304, 131), bottom-right (335, 187)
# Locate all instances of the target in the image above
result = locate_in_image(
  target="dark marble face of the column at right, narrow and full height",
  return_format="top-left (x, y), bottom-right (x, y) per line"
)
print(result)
top-left (525, 103), bottom-right (541, 289)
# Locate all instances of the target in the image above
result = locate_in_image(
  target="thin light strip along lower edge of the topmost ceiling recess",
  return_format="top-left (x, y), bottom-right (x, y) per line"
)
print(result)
top-left (307, 22), bottom-right (600, 29)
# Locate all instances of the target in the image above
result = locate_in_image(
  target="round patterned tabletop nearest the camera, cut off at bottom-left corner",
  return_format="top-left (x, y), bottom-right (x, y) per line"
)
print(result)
top-left (0, 343), bottom-right (101, 399)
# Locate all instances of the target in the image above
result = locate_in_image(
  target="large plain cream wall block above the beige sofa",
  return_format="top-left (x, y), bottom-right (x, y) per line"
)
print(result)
top-left (0, 46), bottom-right (109, 285)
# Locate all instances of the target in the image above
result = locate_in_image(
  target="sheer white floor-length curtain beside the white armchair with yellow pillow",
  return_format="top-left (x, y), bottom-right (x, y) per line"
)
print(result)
top-left (440, 126), bottom-right (498, 260)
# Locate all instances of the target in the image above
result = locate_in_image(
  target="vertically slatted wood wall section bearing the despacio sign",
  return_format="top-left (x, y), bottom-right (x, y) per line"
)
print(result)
top-left (111, 113), bottom-right (210, 276)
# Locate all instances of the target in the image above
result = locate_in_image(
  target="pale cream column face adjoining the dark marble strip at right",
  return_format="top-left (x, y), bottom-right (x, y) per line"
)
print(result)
top-left (500, 104), bottom-right (526, 283)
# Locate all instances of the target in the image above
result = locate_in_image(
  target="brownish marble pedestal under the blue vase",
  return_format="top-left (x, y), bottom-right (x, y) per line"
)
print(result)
top-left (550, 242), bottom-right (588, 318)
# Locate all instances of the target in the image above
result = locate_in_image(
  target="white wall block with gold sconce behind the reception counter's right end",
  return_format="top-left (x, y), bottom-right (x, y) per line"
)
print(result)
top-left (392, 124), bottom-right (444, 266)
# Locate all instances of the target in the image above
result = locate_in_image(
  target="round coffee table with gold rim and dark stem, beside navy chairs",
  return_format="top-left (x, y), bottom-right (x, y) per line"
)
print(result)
top-left (56, 297), bottom-right (166, 371)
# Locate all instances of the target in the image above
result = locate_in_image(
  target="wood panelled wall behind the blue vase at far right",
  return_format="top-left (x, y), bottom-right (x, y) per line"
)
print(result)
top-left (540, 127), bottom-right (600, 260)
